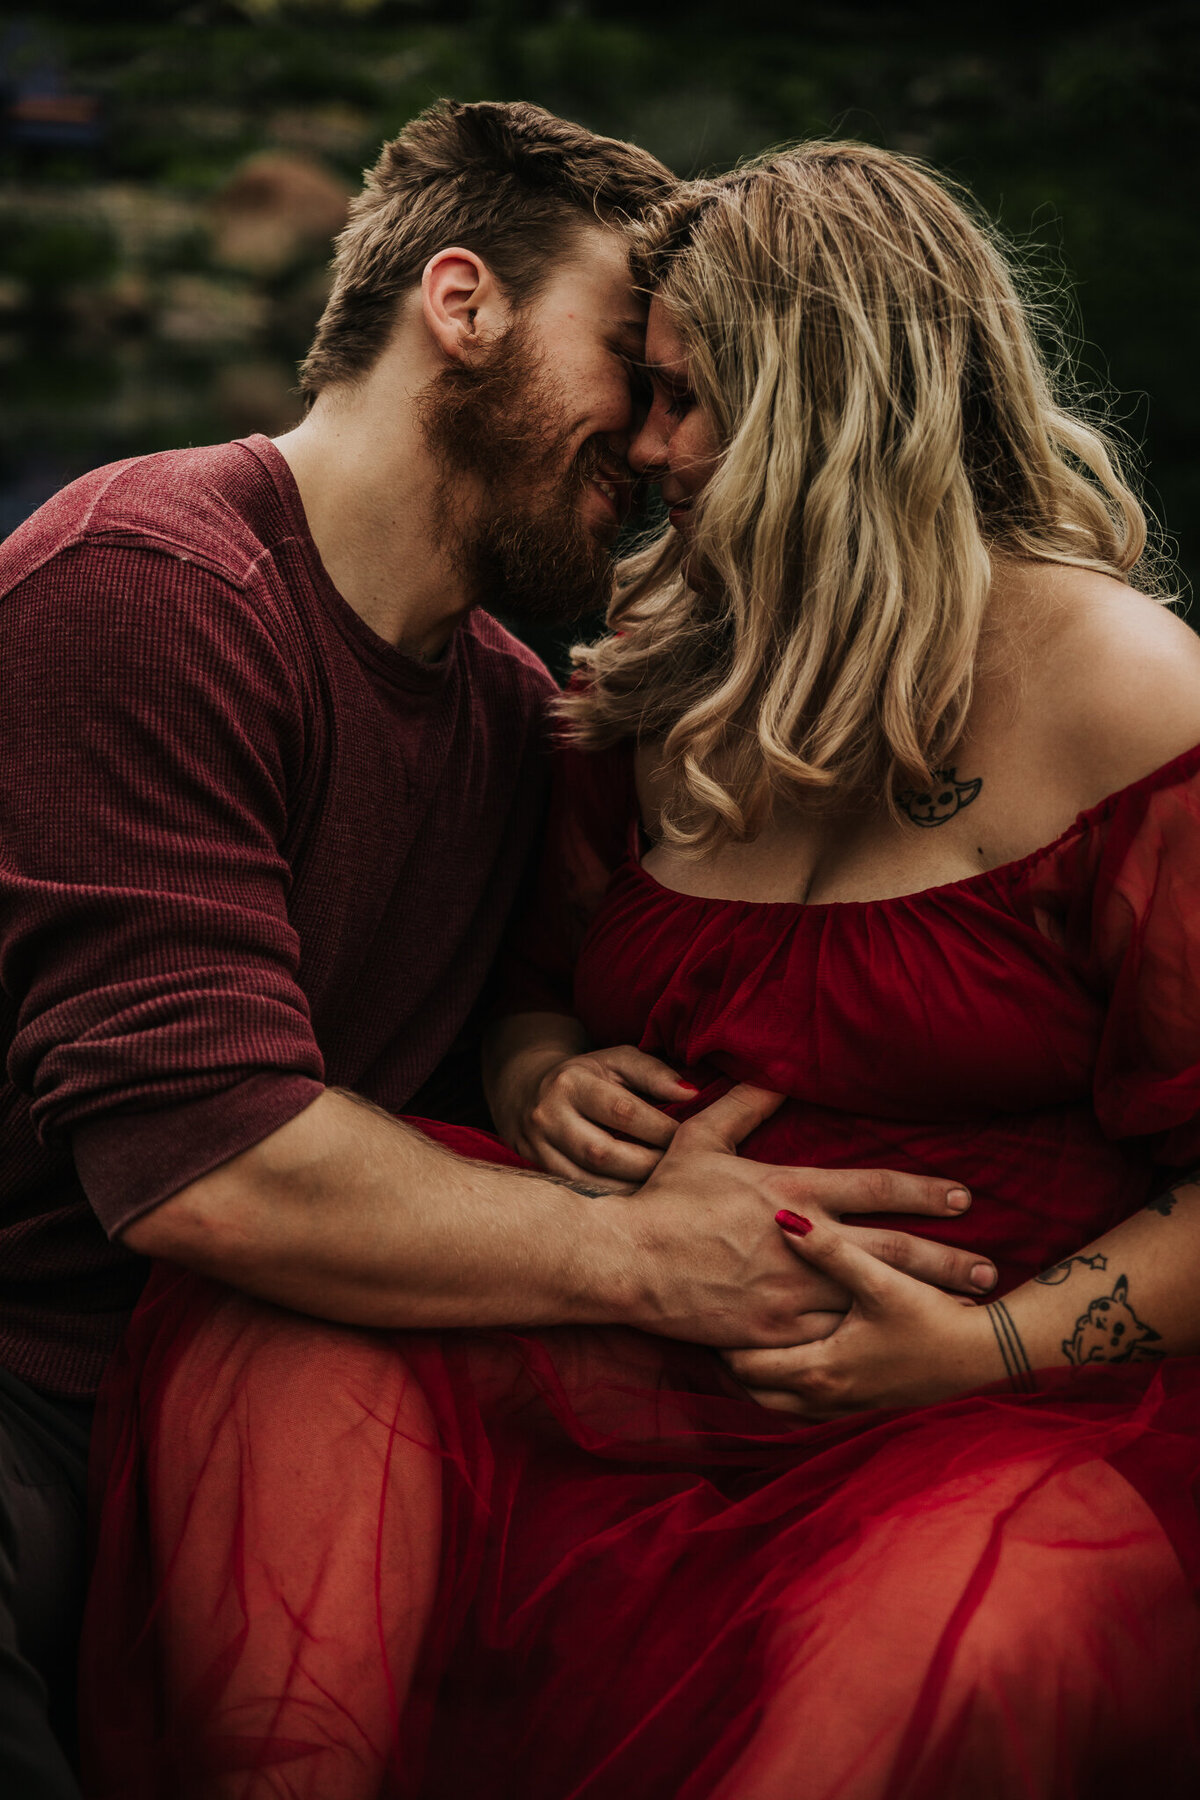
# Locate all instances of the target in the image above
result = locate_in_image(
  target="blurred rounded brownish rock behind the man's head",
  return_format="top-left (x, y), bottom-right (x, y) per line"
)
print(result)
top-left (210, 149), bottom-right (349, 277)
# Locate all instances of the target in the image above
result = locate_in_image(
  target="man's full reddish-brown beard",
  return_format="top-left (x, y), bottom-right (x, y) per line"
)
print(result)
top-left (421, 320), bottom-right (615, 625)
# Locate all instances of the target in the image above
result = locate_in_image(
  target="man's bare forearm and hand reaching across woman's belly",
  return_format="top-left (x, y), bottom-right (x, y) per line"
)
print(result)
top-left (122, 1087), bottom-right (979, 1345)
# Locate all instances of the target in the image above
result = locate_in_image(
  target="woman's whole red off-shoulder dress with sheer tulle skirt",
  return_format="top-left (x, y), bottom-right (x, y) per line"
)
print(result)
top-left (83, 747), bottom-right (1200, 1800)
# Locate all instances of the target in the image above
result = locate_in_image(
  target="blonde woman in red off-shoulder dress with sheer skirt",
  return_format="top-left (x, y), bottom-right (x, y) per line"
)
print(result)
top-left (84, 144), bottom-right (1200, 1800)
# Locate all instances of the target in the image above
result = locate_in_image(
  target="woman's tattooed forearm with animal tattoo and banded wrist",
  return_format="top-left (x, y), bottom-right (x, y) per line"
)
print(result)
top-left (988, 1172), bottom-right (1200, 1388)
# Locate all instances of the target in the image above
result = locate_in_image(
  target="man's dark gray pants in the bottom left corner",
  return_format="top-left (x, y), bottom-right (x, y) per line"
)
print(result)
top-left (0, 1368), bottom-right (92, 1800)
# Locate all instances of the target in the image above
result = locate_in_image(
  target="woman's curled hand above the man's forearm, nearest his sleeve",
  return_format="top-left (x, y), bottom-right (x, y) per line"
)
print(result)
top-left (515, 1044), bottom-right (696, 1186)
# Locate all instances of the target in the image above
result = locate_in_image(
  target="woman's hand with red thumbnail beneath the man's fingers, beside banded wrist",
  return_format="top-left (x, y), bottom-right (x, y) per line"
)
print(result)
top-left (725, 1211), bottom-right (1006, 1420)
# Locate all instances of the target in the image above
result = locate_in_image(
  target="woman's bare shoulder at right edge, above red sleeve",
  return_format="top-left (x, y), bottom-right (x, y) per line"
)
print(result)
top-left (1007, 569), bottom-right (1200, 805)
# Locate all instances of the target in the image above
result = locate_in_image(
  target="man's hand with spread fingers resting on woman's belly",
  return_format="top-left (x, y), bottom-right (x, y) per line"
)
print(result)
top-left (610, 1085), bottom-right (995, 1346)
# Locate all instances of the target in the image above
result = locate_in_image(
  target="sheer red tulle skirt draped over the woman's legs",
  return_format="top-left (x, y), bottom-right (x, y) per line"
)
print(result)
top-left (83, 1132), bottom-right (1200, 1800)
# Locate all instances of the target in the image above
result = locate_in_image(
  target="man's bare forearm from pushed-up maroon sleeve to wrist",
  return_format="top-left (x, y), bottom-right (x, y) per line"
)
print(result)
top-left (124, 1093), bottom-right (630, 1327)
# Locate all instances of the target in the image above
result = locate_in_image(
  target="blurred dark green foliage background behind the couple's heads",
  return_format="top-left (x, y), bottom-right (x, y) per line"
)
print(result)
top-left (0, 0), bottom-right (1200, 630)
